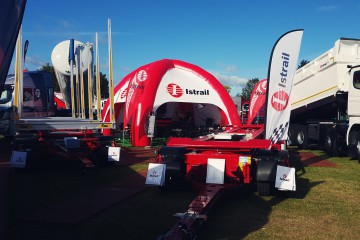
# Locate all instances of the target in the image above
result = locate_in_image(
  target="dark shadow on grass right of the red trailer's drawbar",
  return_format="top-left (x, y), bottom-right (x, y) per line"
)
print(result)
top-left (199, 151), bottom-right (323, 240)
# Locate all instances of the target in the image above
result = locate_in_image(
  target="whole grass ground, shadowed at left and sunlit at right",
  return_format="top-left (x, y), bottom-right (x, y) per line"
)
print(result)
top-left (4, 151), bottom-right (360, 240)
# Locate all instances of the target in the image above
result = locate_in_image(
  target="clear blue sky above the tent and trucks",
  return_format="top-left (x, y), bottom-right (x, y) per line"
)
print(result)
top-left (9, 0), bottom-right (360, 95)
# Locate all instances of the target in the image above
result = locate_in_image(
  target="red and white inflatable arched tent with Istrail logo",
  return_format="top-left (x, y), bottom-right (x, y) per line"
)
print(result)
top-left (102, 59), bottom-right (241, 146)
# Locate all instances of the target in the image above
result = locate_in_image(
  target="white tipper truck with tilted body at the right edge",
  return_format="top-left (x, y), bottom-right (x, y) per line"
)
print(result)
top-left (289, 38), bottom-right (360, 161)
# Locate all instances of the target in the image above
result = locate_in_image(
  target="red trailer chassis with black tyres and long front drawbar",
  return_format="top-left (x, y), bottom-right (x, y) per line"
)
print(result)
top-left (156, 128), bottom-right (290, 239)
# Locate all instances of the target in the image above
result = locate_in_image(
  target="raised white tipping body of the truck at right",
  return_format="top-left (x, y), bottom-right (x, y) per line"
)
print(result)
top-left (291, 39), bottom-right (360, 110)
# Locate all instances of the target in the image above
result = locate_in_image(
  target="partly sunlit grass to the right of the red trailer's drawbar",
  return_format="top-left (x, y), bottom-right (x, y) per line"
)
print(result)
top-left (200, 151), bottom-right (360, 239)
